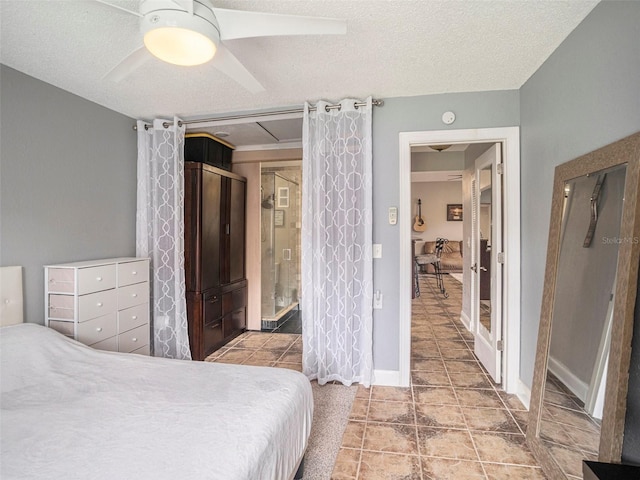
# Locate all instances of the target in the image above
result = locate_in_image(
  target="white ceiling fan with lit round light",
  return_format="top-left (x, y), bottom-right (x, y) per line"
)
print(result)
top-left (95, 0), bottom-right (347, 93)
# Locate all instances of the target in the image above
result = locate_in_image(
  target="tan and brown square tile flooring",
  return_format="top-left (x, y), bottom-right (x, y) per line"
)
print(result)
top-left (207, 275), bottom-right (545, 480)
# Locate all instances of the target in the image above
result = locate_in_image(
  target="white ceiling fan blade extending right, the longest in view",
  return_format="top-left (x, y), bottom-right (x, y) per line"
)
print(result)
top-left (212, 7), bottom-right (347, 40)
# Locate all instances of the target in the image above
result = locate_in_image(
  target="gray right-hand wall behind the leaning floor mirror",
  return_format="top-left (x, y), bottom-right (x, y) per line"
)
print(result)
top-left (520, 1), bottom-right (640, 386)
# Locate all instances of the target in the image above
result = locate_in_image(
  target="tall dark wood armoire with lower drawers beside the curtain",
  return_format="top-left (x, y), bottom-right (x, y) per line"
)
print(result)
top-left (184, 161), bottom-right (247, 360)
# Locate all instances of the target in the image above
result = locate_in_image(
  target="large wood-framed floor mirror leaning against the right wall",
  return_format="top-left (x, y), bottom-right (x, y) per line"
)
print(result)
top-left (527, 132), bottom-right (640, 480)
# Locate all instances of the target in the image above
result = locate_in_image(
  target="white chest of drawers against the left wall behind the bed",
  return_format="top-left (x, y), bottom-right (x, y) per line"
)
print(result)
top-left (44, 257), bottom-right (150, 355)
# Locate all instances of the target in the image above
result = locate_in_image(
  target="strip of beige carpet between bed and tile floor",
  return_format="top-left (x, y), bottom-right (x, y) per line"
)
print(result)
top-left (303, 381), bottom-right (358, 480)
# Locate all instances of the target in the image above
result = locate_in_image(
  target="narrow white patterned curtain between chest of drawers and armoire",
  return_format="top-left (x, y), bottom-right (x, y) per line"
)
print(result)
top-left (136, 118), bottom-right (191, 360)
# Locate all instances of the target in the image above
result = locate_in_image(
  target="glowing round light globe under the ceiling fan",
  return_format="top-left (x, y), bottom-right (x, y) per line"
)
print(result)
top-left (144, 27), bottom-right (217, 67)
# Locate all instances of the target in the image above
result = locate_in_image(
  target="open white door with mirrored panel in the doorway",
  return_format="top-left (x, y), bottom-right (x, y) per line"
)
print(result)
top-left (471, 143), bottom-right (504, 383)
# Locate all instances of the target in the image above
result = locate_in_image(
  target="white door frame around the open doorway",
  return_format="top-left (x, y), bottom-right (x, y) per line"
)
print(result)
top-left (398, 127), bottom-right (521, 393)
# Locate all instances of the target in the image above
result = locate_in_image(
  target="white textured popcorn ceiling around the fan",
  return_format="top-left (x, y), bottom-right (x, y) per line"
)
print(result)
top-left (0, 0), bottom-right (598, 124)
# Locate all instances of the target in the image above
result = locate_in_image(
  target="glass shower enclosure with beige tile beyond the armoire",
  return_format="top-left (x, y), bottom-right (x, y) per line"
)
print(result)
top-left (260, 169), bottom-right (302, 328)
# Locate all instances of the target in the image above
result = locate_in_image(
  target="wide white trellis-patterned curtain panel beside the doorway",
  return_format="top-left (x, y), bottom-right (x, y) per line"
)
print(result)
top-left (301, 98), bottom-right (373, 387)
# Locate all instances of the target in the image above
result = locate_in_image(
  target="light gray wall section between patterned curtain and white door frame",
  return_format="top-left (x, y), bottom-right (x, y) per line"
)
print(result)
top-left (373, 90), bottom-right (520, 370)
